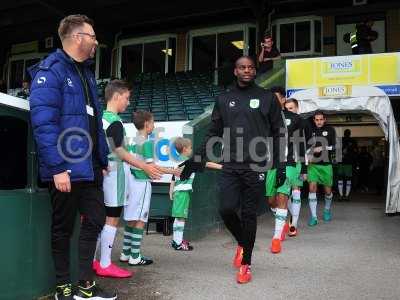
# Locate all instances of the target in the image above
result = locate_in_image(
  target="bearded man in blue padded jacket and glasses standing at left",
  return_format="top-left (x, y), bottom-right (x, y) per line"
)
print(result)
top-left (30, 15), bottom-right (116, 299)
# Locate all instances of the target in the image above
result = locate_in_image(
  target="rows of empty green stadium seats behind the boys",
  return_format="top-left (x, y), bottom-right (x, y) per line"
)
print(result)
top-left (98, 71), bottom-right (223, 122)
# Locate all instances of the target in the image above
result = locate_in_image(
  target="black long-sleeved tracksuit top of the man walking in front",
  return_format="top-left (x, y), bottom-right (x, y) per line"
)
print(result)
top-left (202, 83), bottom-right (284, 169)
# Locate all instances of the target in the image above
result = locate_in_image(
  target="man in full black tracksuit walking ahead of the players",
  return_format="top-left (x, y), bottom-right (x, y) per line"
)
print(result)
top-left (198, 57), bottom-right (286, 265)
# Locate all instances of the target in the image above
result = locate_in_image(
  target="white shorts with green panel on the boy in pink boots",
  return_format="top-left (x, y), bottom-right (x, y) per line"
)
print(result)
top-left (103, 161), bottom-right (131, 207)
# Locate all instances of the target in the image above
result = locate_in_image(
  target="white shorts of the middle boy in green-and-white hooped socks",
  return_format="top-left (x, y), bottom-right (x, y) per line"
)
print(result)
top-left (124, 175), bottom-right (151, 222)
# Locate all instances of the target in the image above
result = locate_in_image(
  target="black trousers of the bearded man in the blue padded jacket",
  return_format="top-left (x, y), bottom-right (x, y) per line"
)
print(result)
top-left (49, 169), bottom-right (106, 285)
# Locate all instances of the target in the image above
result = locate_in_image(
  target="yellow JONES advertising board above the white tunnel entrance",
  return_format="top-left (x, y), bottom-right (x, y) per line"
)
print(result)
top-left (286, 53), bottom-right (400, 97)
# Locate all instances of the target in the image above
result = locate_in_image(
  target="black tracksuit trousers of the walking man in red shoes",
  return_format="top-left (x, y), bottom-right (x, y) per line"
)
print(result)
top-left (218, 168), bottom-right (265, 265)
